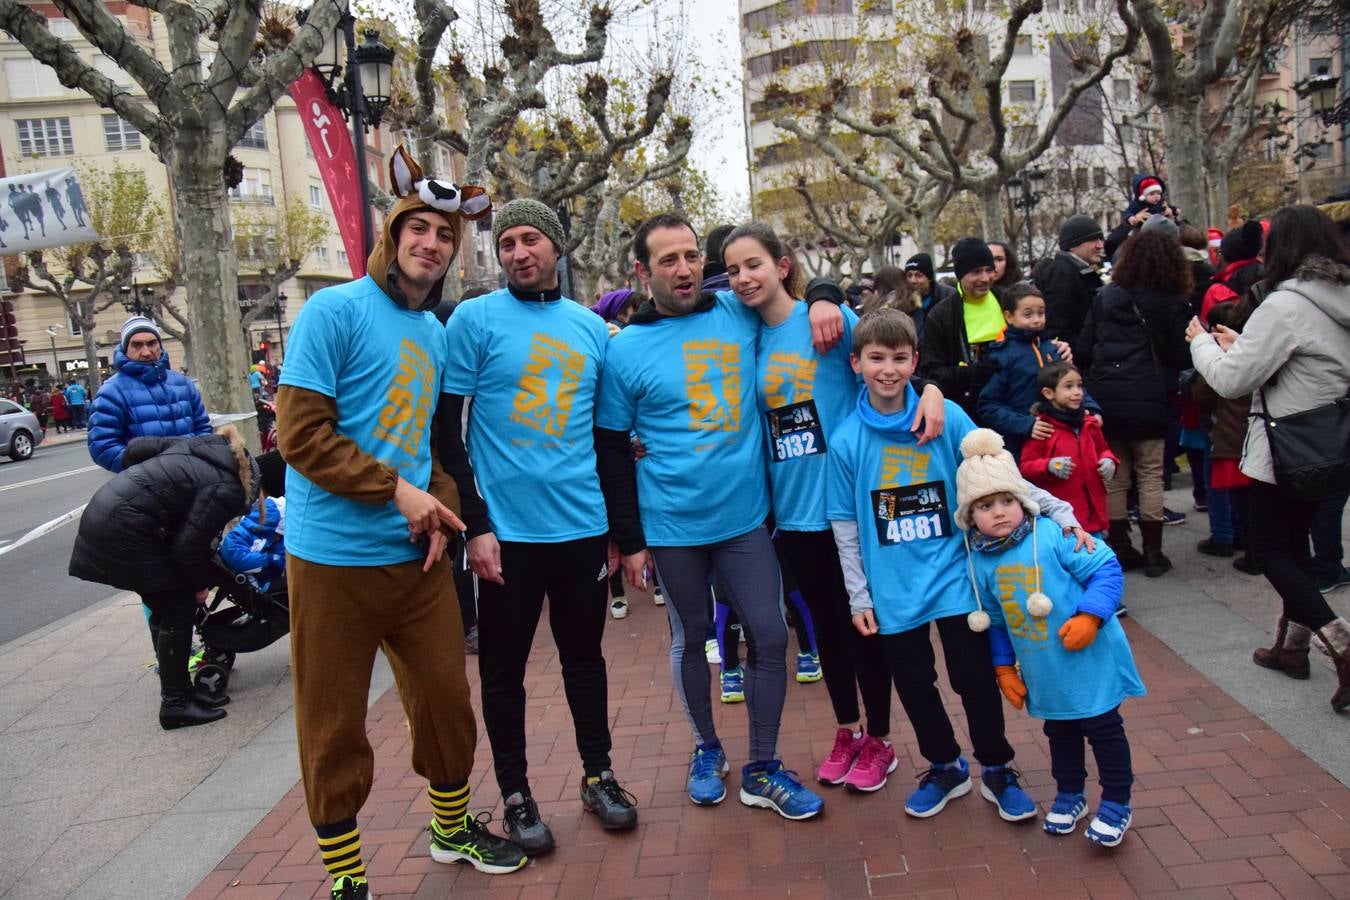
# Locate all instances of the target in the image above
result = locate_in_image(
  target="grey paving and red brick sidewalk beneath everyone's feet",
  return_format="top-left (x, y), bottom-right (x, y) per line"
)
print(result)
top-left (0, 493), bottom-right (1350, 900)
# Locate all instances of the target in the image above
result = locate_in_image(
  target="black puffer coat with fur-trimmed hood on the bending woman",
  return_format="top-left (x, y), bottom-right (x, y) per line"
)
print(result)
top-left (70, 428), bottom-right (257, 594)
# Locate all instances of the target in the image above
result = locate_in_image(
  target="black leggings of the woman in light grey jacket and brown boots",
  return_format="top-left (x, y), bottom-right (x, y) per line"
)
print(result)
top-left (1247, 482), bottom-right (1337, 630)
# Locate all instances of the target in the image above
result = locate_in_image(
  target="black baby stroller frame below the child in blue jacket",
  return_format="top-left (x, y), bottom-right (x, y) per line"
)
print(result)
top-left (189, 559), bottom-right (290, 696)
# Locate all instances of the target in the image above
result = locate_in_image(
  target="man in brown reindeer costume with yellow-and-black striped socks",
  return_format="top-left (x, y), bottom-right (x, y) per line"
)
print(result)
top-left (277, 147), bottom-right (525, 900)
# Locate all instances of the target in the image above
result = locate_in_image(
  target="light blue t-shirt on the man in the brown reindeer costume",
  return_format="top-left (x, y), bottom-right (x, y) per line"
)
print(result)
top-left (281, 275), bottom-right (446, 565)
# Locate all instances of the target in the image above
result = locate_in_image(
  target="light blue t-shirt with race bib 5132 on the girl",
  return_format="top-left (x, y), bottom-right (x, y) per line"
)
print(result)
top-left (756, 302), bottom-right (859, 532)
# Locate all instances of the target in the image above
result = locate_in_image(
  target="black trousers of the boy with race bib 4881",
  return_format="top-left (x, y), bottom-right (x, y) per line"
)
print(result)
top-left (882, 615), bottom-right (1013, 766)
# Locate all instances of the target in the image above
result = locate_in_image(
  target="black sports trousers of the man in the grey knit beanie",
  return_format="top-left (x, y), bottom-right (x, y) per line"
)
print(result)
top-left (478, 534), bottom-right (610, 796)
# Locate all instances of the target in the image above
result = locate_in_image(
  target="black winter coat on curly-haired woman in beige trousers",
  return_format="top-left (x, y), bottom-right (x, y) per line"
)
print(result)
top-left (1073, 285), bottom-right (1189, 441)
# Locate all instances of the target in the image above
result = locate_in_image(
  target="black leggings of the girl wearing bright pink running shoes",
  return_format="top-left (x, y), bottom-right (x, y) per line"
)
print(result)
top-left (778, 530), bottom-right (891, 738)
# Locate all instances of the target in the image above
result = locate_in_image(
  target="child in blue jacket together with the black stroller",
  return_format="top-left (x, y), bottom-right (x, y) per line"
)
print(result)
top-left (190, 467), bottom-right (290, 696)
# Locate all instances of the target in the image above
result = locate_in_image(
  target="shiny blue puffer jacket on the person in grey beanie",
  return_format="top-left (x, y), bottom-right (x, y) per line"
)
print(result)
top-left (89, 348), bottom-right (211, 472)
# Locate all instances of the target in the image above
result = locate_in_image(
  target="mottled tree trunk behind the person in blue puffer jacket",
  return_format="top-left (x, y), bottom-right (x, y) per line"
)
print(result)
top-left (165, 141), bottom-right (258, 447)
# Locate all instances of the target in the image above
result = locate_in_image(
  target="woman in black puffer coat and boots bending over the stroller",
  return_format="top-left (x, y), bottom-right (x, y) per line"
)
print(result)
top-left (70, 428), bottom-right (284, 729)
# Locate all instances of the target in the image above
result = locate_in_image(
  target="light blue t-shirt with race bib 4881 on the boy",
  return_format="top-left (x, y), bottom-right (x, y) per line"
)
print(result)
top-left (825, 386), bottom-right (975, 634)
